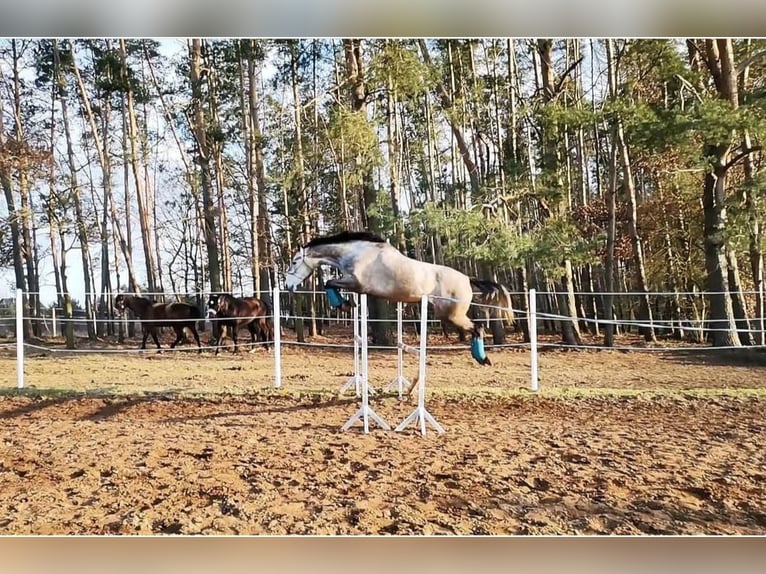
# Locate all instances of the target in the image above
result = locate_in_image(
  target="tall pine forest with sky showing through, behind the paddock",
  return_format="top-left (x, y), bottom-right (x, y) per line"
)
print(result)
top-left (0, 38), bottom-right (766, 346)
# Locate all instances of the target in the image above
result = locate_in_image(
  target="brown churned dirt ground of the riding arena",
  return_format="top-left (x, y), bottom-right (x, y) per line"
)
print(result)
top-left (0, 336), bottom-right (766, 535)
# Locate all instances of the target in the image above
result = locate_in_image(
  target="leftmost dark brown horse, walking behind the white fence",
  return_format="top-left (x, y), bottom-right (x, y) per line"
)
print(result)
top-left (114, 293), bottom-right (203, 353)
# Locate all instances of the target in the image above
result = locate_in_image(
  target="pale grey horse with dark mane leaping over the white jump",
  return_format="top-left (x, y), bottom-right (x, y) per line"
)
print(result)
top-left (286, 231), bottom-right (492, 365)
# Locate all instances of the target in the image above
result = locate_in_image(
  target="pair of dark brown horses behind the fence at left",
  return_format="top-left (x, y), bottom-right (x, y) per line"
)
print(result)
top-left (114, 293), bottom-right (274, 355)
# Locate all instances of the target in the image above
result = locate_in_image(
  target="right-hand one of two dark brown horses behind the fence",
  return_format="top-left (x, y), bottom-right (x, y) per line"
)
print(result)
top-left (207, 293), bottom-right (274, 355)
